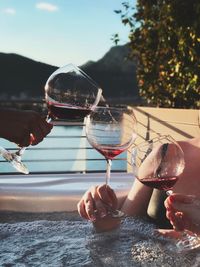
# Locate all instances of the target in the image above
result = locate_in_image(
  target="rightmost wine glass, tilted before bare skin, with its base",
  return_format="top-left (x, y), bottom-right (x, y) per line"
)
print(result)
top-left (131, 135), bottom-right (200, 252)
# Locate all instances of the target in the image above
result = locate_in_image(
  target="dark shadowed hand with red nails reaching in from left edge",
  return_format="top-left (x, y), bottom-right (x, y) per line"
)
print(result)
top-left (0, 109), bottom-right (53, 147)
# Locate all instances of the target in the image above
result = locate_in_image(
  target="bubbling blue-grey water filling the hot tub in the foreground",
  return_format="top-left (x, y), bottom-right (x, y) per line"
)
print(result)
top-left (0, 213), bottom-right (200, 267)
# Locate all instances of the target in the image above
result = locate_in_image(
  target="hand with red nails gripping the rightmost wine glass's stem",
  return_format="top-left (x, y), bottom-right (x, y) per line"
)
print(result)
top-left (165, 194), bottom-right (200, 233)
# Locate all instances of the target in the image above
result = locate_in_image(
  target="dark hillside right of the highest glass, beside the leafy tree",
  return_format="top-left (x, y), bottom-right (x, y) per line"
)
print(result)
top-left (82, 45), bottom-right (138, 101)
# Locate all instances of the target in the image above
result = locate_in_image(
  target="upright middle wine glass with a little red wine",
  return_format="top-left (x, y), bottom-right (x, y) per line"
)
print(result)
top-left (86, 107), bottom-right (137, 217)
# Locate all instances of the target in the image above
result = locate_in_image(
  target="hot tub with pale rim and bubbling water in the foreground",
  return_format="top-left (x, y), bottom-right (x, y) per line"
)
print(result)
top-left (0, 173), bottom-right (200, 267)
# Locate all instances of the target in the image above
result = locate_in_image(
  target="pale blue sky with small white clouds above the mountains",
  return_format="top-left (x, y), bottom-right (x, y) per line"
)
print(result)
top-left (0, 0), bottom-right (134, 66)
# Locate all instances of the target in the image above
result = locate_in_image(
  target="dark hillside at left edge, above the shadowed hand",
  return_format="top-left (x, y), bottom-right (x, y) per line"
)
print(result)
top-left (0, 53), bottom-right (57, 99)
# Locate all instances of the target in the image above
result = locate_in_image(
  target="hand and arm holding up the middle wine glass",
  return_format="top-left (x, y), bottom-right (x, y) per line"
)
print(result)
top-left (77, 180), bottom-right (152, 231)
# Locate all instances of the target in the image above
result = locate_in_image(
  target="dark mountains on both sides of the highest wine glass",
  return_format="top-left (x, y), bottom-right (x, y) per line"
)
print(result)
top-left (0, 45), bottom-right (138, 103)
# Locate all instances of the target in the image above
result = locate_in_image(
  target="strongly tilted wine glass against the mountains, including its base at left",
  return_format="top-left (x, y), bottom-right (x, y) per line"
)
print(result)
top-left (0, 64), bottom-right (102, 174)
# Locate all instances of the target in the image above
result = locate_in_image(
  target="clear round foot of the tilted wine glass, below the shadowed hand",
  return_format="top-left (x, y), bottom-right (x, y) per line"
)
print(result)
top-left (0, 148), bottom-right (29, 174)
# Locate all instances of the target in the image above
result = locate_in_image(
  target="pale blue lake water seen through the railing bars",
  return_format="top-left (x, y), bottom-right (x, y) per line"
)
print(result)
top-left (0, 126), bottom-right (127, 173)
